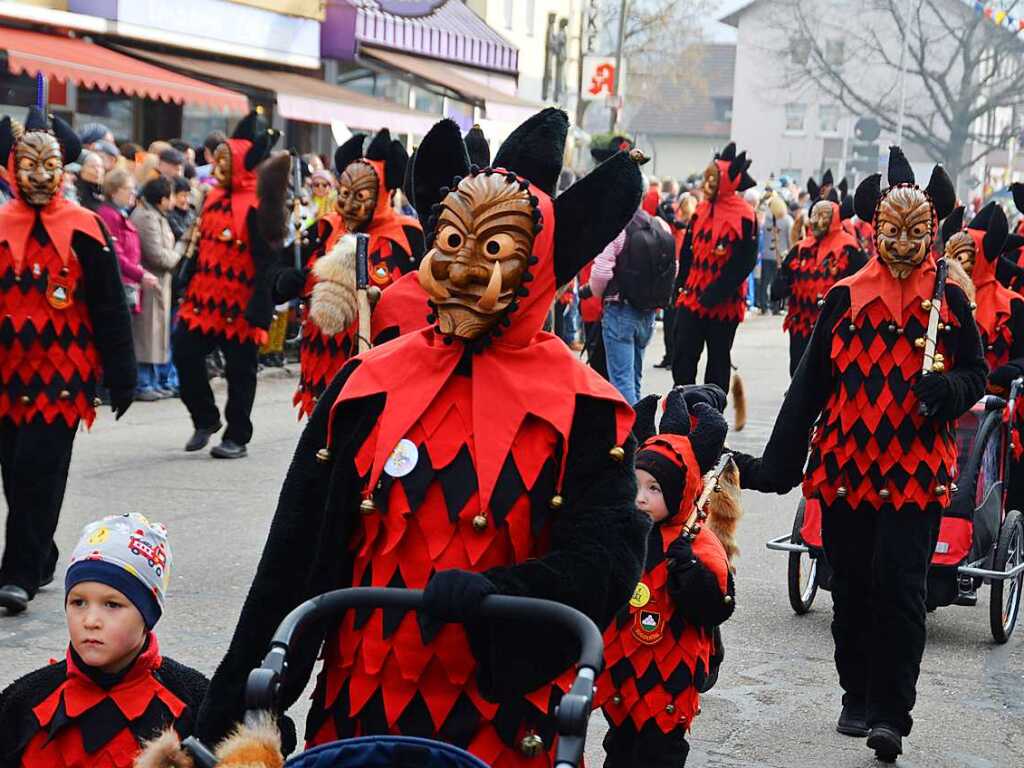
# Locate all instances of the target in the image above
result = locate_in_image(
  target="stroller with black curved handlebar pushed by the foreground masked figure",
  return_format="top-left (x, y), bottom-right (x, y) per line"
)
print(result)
top-left (182, 587), bottom-right (604, 768)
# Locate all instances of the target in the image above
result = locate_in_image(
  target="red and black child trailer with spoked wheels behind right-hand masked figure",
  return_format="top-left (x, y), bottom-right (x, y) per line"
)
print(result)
top-left (767, 379), bottom-right (1024, 643)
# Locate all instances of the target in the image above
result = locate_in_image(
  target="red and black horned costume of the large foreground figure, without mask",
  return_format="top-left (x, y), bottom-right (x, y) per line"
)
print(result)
top-left (193, 110), bottom-right (647, 766)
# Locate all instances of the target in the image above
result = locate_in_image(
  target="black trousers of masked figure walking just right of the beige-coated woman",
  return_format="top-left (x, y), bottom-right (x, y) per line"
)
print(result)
top-left (171, 323), bottom-right (259, 445)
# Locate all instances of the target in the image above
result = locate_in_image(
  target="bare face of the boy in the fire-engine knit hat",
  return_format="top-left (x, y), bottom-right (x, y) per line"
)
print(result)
top-left (65, 582), bottom-right (146, 673)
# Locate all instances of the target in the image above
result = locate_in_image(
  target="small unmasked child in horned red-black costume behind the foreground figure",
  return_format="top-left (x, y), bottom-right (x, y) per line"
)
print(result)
top-left (594, 385), bottom-right (735, 768)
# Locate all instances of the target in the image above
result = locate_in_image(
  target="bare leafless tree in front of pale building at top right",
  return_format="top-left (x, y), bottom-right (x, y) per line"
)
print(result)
top-left (775, 0), bottom-right (1024, 185)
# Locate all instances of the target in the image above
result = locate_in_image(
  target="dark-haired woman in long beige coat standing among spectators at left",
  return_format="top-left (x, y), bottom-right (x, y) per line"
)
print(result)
top-left (131, 176), bottom-right (180, 400)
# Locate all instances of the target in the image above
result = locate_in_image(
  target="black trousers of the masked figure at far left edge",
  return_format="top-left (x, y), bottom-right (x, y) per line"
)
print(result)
top-left (0, 418), bottom-right (78, 597)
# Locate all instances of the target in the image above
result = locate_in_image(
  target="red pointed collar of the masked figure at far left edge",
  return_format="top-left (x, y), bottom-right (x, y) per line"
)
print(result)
top-left (0, 197), bottom-right (106, 271)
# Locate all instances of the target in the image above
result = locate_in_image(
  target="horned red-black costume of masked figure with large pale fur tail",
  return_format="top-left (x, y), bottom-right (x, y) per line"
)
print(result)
top-left (274, 128), bottom-right (427, 417)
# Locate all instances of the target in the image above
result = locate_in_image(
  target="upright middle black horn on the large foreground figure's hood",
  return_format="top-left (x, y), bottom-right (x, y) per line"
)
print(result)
top-left (494, 106), bottom-right (569, 197)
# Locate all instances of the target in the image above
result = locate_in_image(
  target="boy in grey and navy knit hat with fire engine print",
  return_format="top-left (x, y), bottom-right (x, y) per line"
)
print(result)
top-left (0, 513), bottom-right (208, 768)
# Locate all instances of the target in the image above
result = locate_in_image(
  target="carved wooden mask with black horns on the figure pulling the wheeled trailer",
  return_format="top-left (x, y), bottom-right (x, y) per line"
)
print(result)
top-left (854, 146), bottom-right (956, 280)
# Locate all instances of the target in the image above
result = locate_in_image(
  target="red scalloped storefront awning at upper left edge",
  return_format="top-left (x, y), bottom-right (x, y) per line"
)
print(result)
top-left (0, 28), bottom-right (249, 114)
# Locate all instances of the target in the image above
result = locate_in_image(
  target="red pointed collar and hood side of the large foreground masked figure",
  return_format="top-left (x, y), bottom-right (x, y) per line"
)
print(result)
top-left (328, 178), bottom-right (634, 509)
